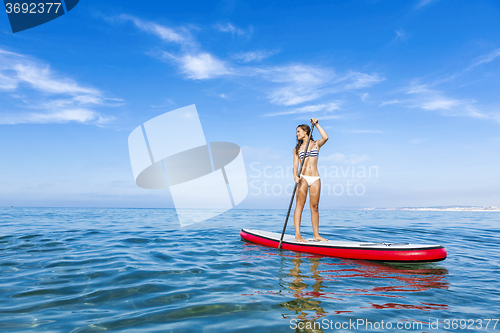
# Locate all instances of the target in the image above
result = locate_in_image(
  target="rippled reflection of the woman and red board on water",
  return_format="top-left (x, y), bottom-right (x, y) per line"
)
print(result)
top-left (273, 253), bottom-right (449, 332)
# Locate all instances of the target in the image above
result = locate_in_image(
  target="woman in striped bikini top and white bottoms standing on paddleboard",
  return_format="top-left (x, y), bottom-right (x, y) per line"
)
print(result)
top-left (293, 118), bottom-right (328, 242)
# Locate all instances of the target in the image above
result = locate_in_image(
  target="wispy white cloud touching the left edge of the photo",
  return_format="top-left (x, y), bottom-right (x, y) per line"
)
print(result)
top-left (0, 49), bottom-right (116, 125)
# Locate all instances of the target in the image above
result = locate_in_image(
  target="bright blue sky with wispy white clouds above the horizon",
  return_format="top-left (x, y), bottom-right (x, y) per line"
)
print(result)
top-left (0, 0), bottom-right (500, 209)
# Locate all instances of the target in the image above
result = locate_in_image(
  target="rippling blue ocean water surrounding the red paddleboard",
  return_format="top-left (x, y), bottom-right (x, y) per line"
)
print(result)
top-left (0, 208), bottom-right (500, 332)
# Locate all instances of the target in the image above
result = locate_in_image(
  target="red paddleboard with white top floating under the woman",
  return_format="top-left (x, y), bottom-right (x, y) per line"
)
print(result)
top-left (240, 229), bottom-right (446, 262)
